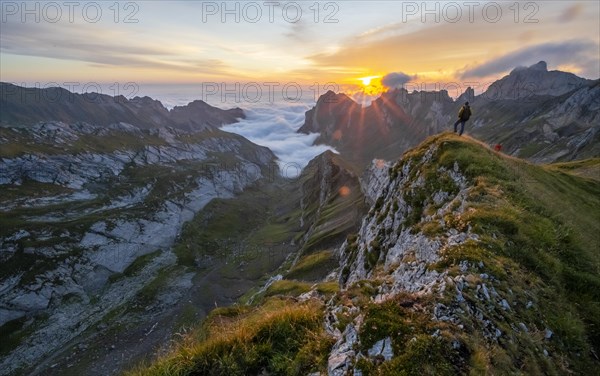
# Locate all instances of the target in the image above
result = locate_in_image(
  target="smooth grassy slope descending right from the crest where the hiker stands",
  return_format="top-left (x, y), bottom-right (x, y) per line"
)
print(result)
top-left (386, 135), bottom-right (600, 374)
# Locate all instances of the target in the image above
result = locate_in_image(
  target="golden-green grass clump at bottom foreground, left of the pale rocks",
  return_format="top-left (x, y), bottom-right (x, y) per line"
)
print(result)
top-left (127, 298), bottom-right (333, 376)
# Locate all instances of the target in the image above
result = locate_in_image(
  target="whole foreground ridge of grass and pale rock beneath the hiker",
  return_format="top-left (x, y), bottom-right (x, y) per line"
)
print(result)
top-left (128, 133), bottom-right (600, 376)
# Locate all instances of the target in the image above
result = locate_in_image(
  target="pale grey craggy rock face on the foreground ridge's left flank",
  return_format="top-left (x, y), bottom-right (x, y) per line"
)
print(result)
top-left (326, 140), bottom-right (477, 375)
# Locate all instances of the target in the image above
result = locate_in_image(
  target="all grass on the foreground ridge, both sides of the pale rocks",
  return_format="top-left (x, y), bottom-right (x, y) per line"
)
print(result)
top-left (124, 134), bottom-right (600, 375)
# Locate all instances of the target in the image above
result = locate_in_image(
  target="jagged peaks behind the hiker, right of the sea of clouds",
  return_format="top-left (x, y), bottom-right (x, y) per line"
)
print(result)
top-left (298, 61), bottom-right (600, 169)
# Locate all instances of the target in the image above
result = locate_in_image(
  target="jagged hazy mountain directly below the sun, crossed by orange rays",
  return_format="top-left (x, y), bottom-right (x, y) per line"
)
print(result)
top-left (298, 89), bottom-right (454, 170)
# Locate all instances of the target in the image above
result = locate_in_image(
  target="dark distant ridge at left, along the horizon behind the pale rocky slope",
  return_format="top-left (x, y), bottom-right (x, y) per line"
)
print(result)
top-left (0, 82), bottom-right (245, 131)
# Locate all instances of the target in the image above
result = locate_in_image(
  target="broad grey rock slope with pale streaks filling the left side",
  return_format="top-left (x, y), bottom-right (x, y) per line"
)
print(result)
top-left (0, 122), bottom-right (277, 374)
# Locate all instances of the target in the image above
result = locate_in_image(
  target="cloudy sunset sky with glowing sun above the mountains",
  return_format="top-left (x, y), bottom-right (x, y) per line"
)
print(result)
top-left (0, 0), bottom-right (600, 97)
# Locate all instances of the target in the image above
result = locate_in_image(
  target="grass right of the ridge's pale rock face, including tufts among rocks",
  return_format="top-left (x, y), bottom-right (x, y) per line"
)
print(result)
top-left (356, 134), bottom-right (600, 375)
